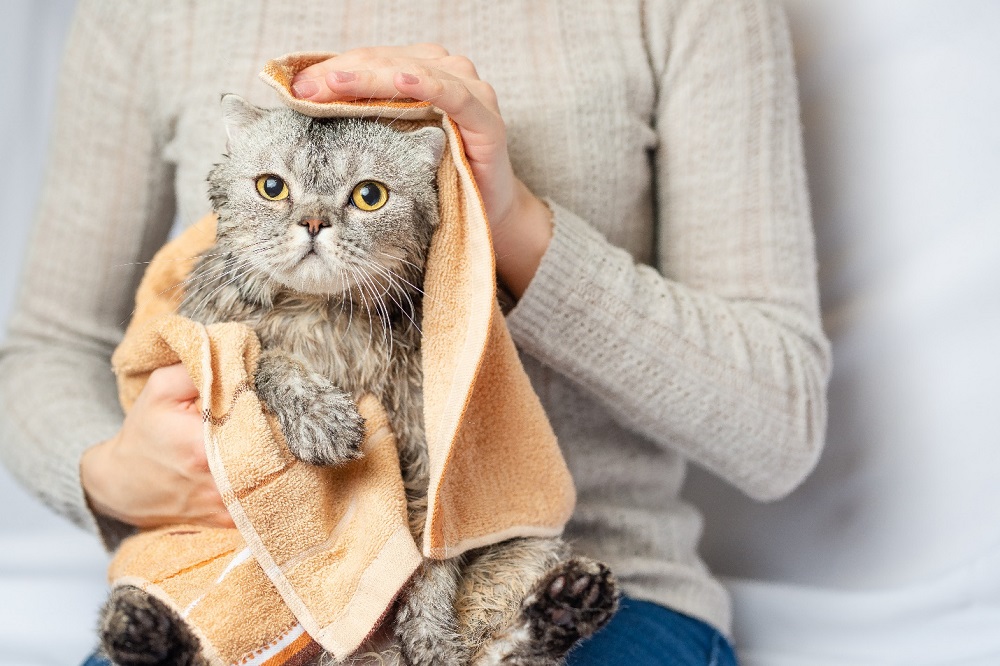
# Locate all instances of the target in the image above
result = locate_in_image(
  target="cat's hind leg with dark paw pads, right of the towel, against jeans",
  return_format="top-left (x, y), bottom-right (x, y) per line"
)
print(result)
top-left (457, 539), bottom-right (618, 666)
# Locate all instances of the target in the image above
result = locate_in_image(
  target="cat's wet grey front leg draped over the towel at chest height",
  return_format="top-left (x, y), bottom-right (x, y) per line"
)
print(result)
top-left (254, 350), bottom-right (364, 465)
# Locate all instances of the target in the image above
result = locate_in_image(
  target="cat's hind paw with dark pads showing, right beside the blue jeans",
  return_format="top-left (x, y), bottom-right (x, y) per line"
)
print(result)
top-left (521, 557), bottom-right (618, 657)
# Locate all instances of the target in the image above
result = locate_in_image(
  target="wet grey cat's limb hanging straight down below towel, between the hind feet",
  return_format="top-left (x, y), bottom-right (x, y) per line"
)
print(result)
top-left (395, 557), bottom-right (469, 666)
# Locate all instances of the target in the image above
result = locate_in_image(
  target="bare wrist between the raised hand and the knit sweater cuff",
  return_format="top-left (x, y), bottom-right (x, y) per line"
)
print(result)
top-left (493, 180), bottom-right (552, 298)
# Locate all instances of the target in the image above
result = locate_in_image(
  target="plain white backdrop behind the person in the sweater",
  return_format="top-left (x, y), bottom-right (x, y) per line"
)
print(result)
top-left (0, 0), bottom-right (1000, 666)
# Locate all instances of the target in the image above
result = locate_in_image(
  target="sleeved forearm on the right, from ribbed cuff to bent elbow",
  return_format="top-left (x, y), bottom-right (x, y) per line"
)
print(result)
top-left (508, 205), bottom-right (828, 499)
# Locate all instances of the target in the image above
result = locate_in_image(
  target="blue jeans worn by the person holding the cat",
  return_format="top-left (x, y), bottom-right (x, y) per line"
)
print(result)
top-left (83, 597), bottom-right (736, 666)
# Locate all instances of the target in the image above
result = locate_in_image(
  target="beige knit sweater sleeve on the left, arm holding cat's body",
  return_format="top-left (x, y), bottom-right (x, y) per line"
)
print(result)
top-left (0, 1), bottom-right (173, 541)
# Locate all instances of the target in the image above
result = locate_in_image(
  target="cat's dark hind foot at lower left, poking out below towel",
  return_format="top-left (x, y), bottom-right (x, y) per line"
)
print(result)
top-left (98, 585), bottom-right (208, 666)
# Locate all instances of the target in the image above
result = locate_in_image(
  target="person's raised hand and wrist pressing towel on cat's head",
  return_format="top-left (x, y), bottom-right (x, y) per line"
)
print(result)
top-left (292, 44), bottom-right (552, 297)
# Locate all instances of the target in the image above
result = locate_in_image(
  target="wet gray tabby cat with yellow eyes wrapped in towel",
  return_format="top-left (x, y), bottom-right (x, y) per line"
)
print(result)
top-left (100, 95), bottom-right (617, 666)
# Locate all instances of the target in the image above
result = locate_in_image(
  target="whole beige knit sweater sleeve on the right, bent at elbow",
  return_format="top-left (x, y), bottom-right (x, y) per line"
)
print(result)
top-left (508, 0), bottom-right (830, 500)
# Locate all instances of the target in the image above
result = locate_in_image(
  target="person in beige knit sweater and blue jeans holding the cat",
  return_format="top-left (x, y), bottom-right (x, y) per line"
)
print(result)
top-left (0, 0), bottom-right (829, 664)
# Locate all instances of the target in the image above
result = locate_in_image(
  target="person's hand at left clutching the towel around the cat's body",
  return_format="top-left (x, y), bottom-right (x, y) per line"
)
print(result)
top-left (80, 365), bottom-right (234, 527)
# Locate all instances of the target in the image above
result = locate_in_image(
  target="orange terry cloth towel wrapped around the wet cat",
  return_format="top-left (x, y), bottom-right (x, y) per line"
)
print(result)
top-left (109, 53), bottom-right (575, 666)
